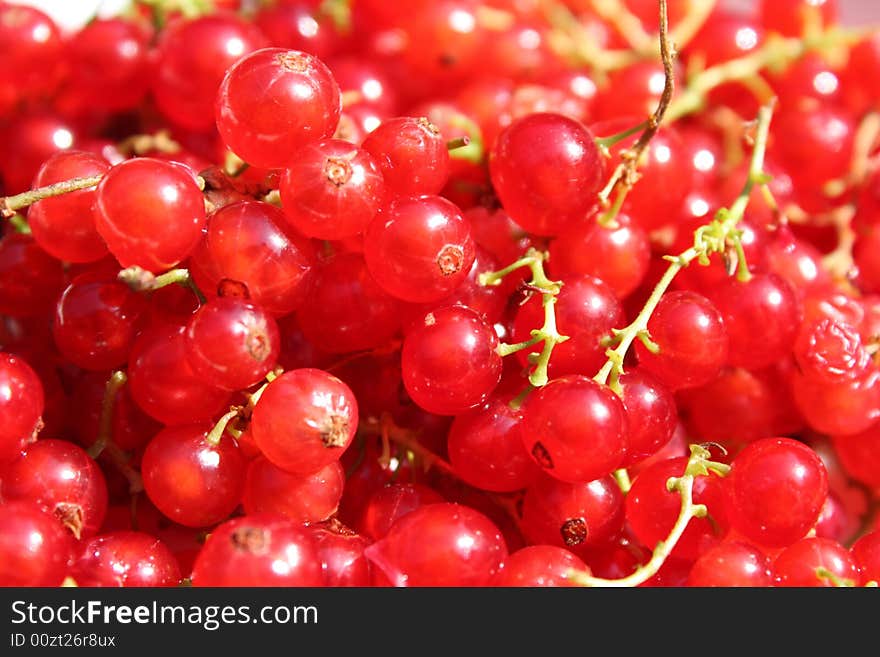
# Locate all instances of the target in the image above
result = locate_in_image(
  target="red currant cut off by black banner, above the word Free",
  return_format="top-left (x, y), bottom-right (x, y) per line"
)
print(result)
top-left (71, 531), bottom-right (180, 587)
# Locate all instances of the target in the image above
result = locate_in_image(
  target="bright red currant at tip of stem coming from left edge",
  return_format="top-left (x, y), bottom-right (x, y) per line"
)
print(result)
top-left (95, 157), bottom-right (206, 273)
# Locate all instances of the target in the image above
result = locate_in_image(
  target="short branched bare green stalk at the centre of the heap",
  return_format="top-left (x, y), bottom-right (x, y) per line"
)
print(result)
top-left (479, 249), bottom-right (568, 388)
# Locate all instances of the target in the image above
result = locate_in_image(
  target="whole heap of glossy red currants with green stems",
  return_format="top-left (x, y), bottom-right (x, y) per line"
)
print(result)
top-left (0, 0), bottom-right (880, 586)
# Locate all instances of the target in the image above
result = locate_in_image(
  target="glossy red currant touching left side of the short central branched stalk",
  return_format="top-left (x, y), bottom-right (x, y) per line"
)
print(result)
top-left (401, 306), bottom-right (502, 415)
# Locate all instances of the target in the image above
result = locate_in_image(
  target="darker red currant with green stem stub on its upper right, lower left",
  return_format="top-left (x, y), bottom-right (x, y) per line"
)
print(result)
top-left (141, 424), bottom-right (246, 527)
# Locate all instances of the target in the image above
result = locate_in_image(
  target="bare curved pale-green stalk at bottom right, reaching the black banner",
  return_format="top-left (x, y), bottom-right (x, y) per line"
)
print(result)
top-left (569, 445), bottom-right (730, 588)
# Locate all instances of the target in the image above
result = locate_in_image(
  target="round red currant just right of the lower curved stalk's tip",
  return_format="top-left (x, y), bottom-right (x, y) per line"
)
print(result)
top-left (725, 438), bottom-right (828, 547)
